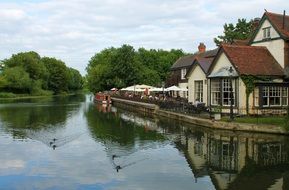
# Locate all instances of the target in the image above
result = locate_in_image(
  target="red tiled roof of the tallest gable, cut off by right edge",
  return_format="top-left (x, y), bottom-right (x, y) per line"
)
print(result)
top-left (265, 12), bottom-right (289, 38)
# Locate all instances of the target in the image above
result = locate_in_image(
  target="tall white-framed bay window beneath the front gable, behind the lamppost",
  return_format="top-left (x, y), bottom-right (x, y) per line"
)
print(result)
top-left (211, 78), bottom-right (235, 106)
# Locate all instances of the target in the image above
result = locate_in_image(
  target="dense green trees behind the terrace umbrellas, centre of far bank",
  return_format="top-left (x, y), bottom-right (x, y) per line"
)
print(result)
top-left (86, 45), bottom-right (184, 92)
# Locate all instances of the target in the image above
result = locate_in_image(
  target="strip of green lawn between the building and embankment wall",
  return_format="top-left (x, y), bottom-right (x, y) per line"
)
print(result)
top-left (222, 116), bottom-right (286, 126)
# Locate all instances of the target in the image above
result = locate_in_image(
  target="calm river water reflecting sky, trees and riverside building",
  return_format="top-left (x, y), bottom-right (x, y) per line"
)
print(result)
top-left (0, 95), bottom-right (289, 190)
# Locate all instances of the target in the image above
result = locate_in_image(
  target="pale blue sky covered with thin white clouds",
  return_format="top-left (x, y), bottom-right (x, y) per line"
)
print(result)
top-left (0, 0), bottom-right (289, 74)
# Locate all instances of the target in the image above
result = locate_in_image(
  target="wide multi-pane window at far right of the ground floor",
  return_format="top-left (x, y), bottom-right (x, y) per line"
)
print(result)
top-left (262, 86), bottom-right (288, 107)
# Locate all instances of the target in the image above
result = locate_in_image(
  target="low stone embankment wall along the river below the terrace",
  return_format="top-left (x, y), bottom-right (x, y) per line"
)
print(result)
top-left (112, 97), bottom-right (289, 135)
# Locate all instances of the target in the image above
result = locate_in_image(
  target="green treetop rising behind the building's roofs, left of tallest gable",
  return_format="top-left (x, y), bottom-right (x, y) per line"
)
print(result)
top-left (214, 18), bottom-right (253, 46)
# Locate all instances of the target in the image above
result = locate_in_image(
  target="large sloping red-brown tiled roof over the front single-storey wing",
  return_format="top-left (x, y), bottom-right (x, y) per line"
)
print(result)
top-left (222, 45), bottom-right (284, 76)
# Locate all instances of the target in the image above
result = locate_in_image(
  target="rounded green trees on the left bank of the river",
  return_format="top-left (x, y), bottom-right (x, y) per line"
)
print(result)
top-left (0, 52), bottom-right (83, 95)
